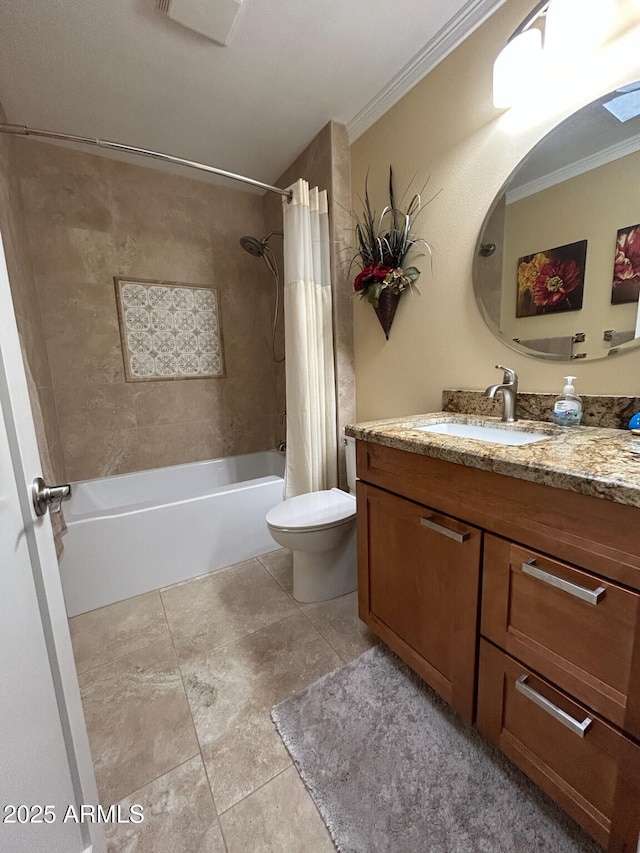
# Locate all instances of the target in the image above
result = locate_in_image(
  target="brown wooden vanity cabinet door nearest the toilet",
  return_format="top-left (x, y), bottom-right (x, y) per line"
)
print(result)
top-left (358, 482), bottom-right (482, 722)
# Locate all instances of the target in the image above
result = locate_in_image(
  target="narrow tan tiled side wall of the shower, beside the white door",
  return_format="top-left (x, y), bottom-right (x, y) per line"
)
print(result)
top-left (0, 106), bottom-right (67, 483)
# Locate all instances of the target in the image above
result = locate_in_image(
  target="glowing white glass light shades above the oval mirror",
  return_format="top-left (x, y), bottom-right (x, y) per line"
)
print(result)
top-left (493, 0), bottom-right (620, 109)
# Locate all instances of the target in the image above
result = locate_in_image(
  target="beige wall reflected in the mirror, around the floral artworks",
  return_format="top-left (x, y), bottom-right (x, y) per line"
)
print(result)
top-left (500, 153), bottom-right (640, 358)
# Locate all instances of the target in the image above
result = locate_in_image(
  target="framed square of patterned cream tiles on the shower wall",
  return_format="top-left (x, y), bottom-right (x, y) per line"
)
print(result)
top-left (115, 278), bottom-right (224, 382)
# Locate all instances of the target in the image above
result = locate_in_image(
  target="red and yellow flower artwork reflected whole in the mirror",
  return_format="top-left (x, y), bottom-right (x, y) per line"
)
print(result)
top-left (516, 240), bottom-right (587, 317)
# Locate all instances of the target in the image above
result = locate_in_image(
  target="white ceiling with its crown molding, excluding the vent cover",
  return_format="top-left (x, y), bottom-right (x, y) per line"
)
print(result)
top-left (0, 0), bottom-right (505, 187)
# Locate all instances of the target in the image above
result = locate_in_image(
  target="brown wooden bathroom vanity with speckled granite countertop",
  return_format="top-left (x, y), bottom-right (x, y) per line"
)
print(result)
top-left (347, 413), bottom-right (640, 853)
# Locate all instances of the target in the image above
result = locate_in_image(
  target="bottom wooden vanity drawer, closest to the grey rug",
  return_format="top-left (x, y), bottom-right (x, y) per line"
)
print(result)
top-left (477, 640), bottom-right (640, 850)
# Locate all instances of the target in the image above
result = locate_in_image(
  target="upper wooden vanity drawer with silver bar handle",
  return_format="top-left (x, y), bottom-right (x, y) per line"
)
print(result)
top-left (481, 535), bottom-right (640, 737)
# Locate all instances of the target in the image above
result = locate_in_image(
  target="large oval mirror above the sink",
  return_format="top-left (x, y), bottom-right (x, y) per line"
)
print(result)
top-left (473, 82), bottom-right (640, 361)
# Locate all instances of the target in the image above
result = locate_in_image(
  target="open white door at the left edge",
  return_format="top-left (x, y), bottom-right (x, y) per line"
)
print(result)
top-left (0, 235), bottom-right (105, 853)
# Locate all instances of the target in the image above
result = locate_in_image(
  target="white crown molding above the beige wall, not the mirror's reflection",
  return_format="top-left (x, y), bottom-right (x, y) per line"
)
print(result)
top-left (347, 0), bottom-right (506, 144)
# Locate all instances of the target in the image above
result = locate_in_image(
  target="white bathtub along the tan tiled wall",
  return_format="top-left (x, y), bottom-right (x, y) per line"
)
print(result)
top-left (60, 450), bottom-right (284, 616)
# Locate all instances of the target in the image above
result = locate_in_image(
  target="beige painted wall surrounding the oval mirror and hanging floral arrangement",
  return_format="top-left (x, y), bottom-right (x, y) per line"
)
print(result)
top-left (351, 0), bottom-right (640, 420)
